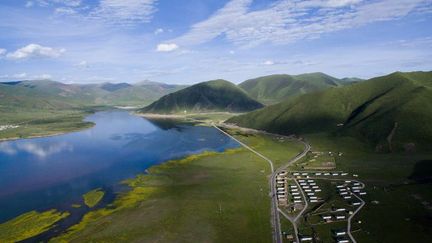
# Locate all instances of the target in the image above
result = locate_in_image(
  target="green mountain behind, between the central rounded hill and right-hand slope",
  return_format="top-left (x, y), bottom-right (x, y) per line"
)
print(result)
top-left (239, 73), bottom-right (344, 104)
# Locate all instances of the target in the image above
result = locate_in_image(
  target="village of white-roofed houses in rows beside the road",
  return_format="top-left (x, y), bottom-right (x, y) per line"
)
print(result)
top-left (276, 170), bottom-right (367, 243)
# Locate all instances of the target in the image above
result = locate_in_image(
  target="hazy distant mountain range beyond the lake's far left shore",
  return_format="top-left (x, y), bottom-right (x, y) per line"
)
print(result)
top-left (0, 80), bottom-right (186, 108)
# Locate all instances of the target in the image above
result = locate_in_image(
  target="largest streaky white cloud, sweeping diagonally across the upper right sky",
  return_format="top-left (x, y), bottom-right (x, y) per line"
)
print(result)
top-left (171, 0), bottom-right (432, 47)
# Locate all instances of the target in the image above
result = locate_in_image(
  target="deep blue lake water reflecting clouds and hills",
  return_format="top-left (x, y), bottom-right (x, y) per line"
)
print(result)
top-left (0, 111), bottom-right (238, 223)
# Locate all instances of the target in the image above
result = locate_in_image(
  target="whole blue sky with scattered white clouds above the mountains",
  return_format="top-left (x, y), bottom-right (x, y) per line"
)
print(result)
top-left (0, 0), bottom-right (432, 84)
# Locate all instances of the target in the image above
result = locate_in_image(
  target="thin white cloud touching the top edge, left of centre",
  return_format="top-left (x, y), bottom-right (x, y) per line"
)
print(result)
top-left (90, 0), bottom-right (157, 25)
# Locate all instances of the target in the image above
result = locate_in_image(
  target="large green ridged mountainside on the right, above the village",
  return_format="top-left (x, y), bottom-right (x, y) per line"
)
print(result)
top-left (227, 72), bottom-right (432, 148)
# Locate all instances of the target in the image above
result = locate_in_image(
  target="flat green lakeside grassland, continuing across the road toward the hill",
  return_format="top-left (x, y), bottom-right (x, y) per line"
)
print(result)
top-left (48, 131), bottom-right (303, 242)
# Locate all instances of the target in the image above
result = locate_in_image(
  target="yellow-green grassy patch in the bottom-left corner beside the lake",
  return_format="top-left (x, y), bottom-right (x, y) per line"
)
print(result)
top-left (0, 210), bottom-right (69, 243)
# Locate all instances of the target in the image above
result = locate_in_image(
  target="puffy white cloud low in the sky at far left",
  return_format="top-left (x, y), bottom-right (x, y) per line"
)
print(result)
top-left (7, 44), bottom-right (66, 60)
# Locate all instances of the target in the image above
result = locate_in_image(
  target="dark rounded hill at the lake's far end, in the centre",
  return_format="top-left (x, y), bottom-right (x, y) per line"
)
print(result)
top-left (141, 80), bottom-right (263, 113)
